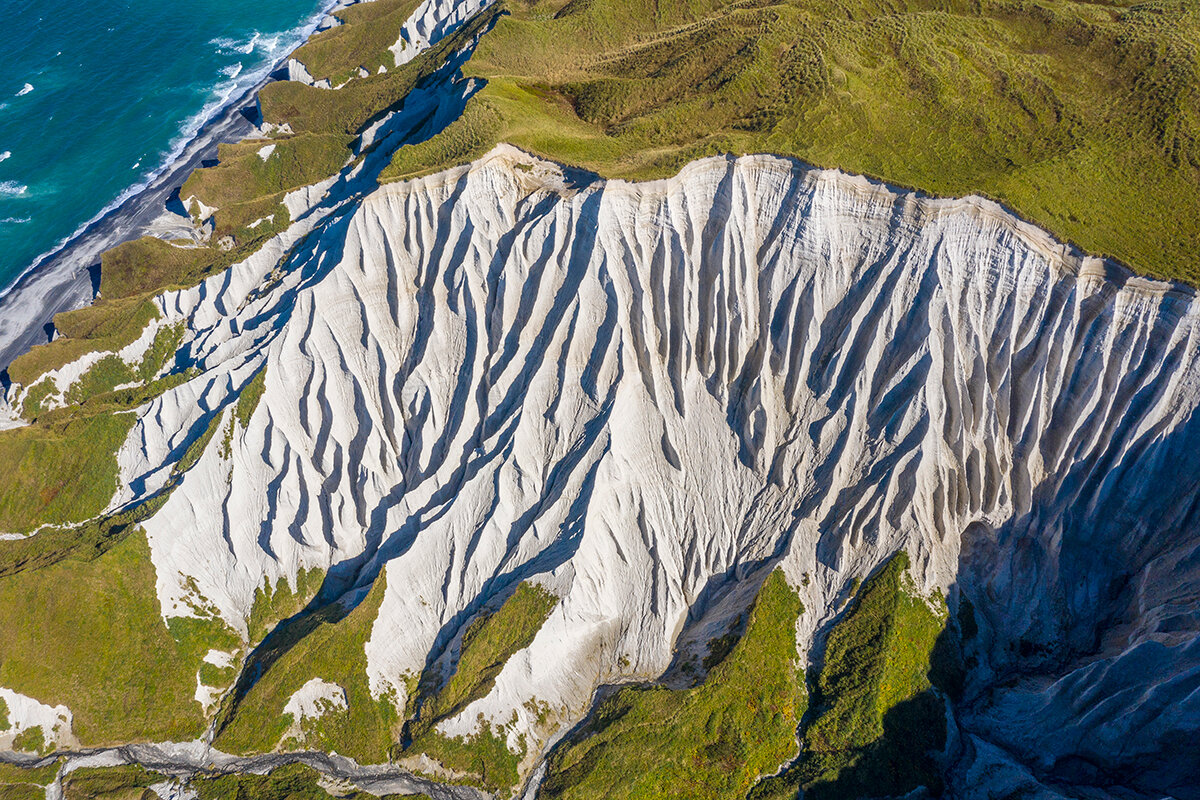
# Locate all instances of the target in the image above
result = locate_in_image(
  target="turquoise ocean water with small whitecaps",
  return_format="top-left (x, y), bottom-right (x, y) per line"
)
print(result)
top-left (0, 0), bottom-right (331, 291)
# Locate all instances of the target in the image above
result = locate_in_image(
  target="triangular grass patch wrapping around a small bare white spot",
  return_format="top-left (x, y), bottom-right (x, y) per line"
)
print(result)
top-left (216, 576), bottom-right (400, 764)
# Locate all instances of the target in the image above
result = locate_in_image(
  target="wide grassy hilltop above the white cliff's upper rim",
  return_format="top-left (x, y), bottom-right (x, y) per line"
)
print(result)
top-left (384, 0), bottom-right (1200, 283)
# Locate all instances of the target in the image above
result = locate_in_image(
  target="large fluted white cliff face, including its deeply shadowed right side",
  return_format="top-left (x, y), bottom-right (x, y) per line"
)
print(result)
top-left (100, 148), bottom-right (1200, 796)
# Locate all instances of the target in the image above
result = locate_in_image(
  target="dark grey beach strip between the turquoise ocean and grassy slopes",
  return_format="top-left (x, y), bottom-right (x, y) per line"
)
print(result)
top-left (0, 0), bottom-right (352, 371)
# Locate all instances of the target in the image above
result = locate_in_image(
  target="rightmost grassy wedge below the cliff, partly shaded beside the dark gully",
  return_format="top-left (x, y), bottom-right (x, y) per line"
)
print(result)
top-left (751, 552), bottom-right (948, 800)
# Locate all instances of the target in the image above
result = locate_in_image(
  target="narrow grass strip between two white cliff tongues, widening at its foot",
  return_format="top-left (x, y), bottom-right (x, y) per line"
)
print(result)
top-left (408, 583), bottom-right (558, 792)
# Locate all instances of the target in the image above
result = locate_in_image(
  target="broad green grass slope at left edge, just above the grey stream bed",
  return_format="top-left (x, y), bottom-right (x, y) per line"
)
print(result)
top-left (0, 531), bottom-right (239, 746)
